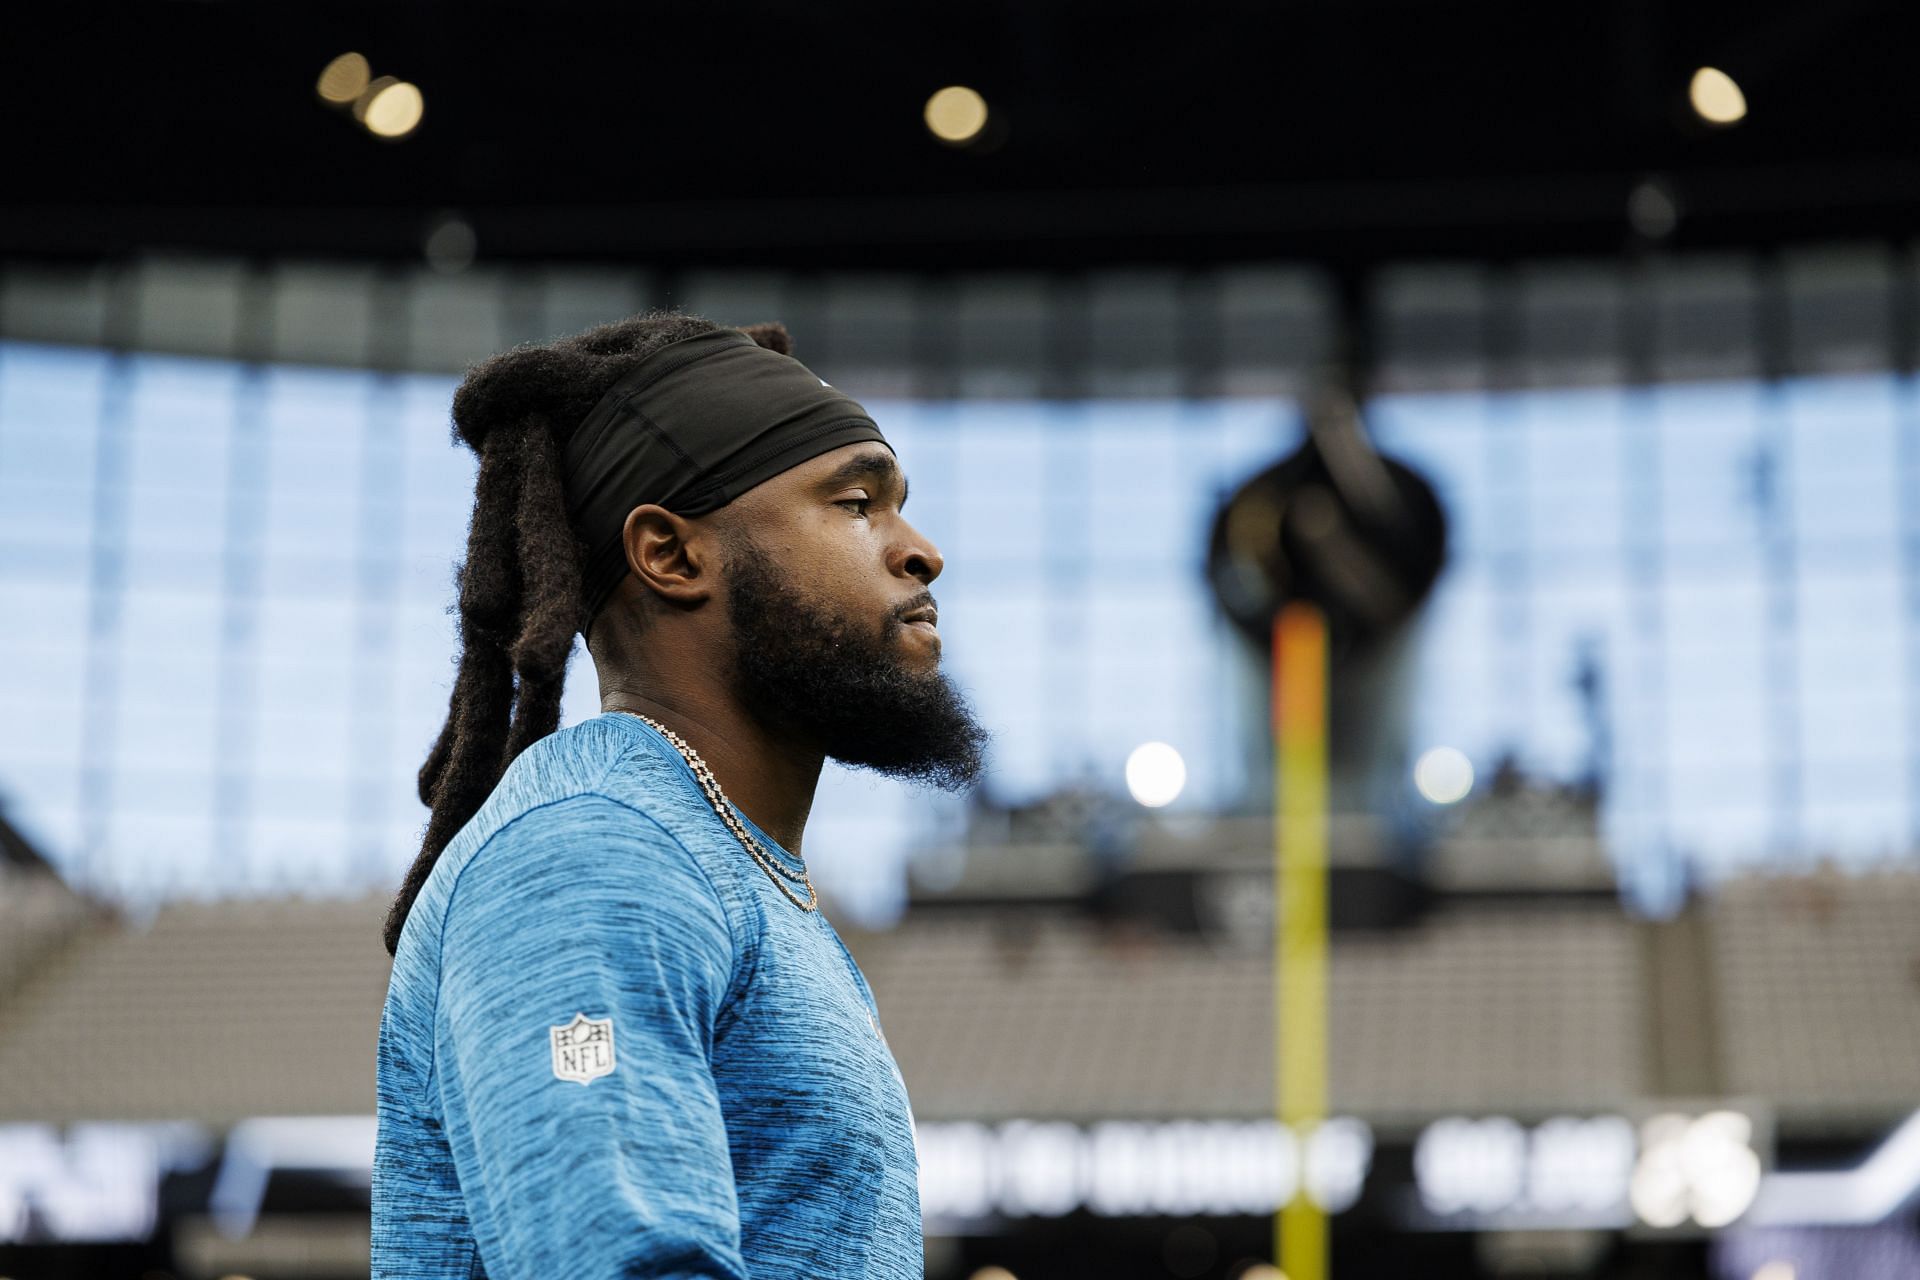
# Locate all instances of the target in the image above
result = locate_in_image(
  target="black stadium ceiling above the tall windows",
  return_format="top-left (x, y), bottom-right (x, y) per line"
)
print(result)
top-left (15, 0), bottom-right (1920, 269)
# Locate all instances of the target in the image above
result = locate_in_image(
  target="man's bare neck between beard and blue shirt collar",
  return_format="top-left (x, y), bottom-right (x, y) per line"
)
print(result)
top-left (601, 672), bottom-right (824, 856)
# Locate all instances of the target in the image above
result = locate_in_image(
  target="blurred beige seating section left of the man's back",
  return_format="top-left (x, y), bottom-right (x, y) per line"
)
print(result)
top-left (0, 894), bottom-right (388, 1125)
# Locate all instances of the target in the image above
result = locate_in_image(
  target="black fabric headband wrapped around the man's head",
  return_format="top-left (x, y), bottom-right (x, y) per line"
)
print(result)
top-left (561, 328), bottom-right (893, 633)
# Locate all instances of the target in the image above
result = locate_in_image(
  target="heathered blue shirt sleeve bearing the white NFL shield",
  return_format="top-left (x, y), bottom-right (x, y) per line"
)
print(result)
top-left (434, 796), bottom-right (747, 1280)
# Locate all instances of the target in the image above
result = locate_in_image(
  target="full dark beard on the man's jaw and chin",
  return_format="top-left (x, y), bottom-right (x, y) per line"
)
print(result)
top-left (726, 535), bottom-right (989, 791)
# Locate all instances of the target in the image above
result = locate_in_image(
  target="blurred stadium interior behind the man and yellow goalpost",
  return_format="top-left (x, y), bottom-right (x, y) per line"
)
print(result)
top-left (0, 0), bottom-right (1920, 1280)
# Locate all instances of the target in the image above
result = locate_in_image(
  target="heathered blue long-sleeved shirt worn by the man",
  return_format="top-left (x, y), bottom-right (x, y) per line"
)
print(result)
top-left (372, 712), bottom-right (922, 1280)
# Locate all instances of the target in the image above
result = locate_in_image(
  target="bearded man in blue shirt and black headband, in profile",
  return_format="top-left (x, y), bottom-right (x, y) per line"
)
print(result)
top-left (372, 313), bottom-right (985, 1280)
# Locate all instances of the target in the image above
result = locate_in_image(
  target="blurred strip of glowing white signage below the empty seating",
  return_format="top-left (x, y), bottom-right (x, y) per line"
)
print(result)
top-left (0, 1103), bottom-right (1920, 1245)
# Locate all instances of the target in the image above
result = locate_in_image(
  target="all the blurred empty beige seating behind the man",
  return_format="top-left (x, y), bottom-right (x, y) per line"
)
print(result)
top-left (0, 871), bottom-right (1920, 1126)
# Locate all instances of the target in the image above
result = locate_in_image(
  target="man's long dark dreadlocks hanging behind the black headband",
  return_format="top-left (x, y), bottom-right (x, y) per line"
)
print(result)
top-left (384, 309), bottom-right (793, 956)
